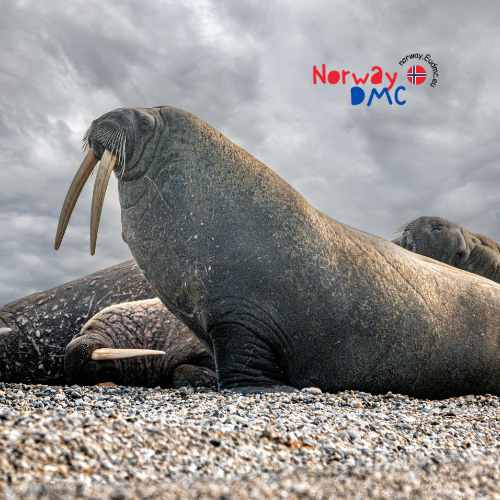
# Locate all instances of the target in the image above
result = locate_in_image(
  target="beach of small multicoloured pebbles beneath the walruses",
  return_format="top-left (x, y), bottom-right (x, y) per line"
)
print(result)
top-left (0, 383), bottom-right (500, 500)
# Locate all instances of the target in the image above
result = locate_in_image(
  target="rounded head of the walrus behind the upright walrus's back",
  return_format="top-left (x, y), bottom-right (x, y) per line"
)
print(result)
top-left (395, 217), bottom-right (470, 267)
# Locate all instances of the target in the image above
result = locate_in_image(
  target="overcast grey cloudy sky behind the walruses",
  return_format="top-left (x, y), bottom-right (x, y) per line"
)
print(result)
top-left (0, 0), bottom-right (500, 304)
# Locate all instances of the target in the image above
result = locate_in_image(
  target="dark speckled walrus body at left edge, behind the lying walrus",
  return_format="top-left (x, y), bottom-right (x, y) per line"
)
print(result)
top-left (0, 260), bottom-right (152, 384)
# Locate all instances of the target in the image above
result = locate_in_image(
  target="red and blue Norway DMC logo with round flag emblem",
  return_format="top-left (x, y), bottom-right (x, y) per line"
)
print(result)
top-left (312, 53), bottom-right (439, 107)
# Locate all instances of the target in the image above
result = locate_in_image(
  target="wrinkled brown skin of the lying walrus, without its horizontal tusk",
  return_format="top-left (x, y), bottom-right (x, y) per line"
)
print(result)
top-left (64, 298), bottom-right (216, 387)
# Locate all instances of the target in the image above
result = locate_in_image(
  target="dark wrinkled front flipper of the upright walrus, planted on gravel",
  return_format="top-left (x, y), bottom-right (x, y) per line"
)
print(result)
top-left (210, 318), bottom-right (294, 394)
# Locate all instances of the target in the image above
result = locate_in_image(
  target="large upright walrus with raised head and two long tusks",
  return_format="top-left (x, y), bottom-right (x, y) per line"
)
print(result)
top-left (55, 106), bottom-right (500, 398)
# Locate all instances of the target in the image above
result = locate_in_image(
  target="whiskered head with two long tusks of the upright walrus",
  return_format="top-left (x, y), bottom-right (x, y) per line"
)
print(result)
top-left (54, 108), bottom-right (158, 255)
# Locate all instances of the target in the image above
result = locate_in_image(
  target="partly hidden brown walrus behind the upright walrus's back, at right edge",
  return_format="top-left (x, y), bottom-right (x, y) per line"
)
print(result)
top-left (394, 217), bottom-right (500, 283)
